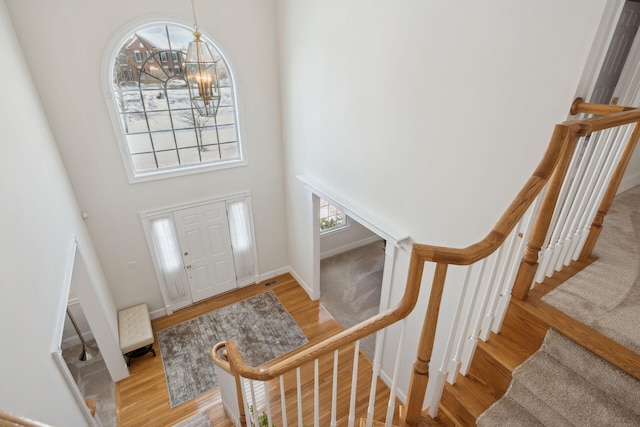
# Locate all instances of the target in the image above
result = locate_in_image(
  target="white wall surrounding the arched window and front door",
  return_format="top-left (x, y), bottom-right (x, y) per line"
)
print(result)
top-left (7, 0), bottom-right (287, 311)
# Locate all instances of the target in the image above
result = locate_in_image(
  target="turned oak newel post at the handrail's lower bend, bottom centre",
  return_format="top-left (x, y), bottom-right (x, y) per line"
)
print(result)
top-left (404, 262), bottom-right (447, 426)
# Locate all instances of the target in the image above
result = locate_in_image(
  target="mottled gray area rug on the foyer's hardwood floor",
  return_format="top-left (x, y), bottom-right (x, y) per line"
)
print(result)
top-left (157, 291), bottom-right (308, 408)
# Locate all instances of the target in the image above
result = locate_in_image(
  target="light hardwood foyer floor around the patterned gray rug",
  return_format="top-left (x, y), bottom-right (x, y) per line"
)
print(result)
top-left (116, 274), bottom-right (451, 427)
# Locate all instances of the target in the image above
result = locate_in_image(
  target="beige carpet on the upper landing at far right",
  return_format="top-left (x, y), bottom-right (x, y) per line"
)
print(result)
top-left (542, 186), bottom-right (640, 353)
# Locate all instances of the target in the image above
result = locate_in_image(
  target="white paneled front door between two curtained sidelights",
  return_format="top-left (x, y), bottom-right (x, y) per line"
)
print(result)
top-left (173, 202), bottom-right (237, 302)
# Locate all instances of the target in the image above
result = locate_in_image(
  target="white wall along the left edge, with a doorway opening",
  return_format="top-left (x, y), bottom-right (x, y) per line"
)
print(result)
top-left (0, 0), bottom-right (119, 426)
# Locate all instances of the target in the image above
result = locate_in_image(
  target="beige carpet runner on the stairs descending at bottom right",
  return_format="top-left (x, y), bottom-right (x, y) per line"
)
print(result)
top-left (477, 329), bottom-right (640, 427)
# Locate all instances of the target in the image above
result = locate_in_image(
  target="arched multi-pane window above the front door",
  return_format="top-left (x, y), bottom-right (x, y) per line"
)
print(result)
top-left (108, 22), bottom-right (244, 182)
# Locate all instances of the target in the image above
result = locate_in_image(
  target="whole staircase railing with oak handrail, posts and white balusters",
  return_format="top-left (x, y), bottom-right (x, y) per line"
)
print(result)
top-left (211, 99), bottom-right (640, 426)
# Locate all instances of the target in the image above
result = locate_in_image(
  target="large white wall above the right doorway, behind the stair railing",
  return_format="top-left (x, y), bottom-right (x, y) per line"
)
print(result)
top-left (278, 0), bottom-right (604, 406)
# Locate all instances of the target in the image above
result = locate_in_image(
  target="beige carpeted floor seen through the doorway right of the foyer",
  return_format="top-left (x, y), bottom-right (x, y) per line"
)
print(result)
top-left (320, 240), bottom-right (385, 360)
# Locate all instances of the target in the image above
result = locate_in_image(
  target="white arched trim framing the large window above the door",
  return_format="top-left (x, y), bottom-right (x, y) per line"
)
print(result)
top-left (100, 14), bottom-right (249, 184)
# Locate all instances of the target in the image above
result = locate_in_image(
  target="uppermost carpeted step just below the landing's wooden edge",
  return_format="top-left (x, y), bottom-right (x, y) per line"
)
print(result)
top-left (541, 329), bottom-right (640, 415)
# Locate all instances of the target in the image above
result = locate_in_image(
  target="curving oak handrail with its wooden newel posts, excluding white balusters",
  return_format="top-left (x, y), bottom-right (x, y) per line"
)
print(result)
top-left (211, 99), bottom-right (640, 426)
